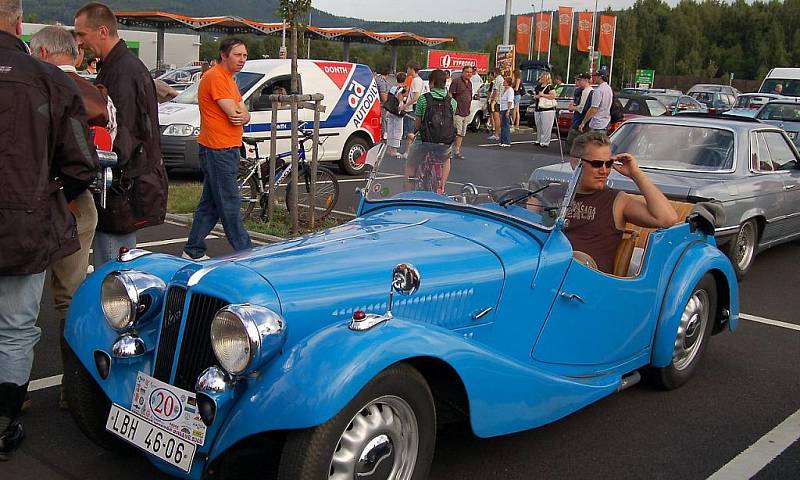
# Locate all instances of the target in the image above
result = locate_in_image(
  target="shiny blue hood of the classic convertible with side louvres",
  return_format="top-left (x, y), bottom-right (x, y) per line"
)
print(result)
top-left (231, 216), bottom-right (504, 340)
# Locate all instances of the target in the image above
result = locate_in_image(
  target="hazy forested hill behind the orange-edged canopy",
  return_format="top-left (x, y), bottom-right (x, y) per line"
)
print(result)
top-left (23, 0), bottom-right (503, 50)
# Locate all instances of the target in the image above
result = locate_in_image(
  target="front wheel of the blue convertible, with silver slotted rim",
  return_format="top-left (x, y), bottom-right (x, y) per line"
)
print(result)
top-left (278, 364), bottom-right (436, 480)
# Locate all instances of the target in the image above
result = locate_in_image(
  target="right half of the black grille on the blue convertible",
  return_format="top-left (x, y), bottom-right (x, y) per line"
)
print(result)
top-left (173, 294), bottom-right (228, 391)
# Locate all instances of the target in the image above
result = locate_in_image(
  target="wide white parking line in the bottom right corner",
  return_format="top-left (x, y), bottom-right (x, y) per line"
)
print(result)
top-left (707, 410), bottom-right (800, 480)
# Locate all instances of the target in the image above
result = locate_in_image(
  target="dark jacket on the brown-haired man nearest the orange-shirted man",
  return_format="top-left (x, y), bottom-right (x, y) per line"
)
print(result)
top-left (95, 40), bottom-right (167, 233)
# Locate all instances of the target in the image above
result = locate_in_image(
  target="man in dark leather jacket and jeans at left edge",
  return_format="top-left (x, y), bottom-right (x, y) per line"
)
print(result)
top-left (0, 0), bottom-right (98, 460)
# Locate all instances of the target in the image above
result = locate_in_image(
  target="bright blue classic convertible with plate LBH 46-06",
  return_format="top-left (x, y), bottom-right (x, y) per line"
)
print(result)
top-left (64, 145), bottom-right (739, 480)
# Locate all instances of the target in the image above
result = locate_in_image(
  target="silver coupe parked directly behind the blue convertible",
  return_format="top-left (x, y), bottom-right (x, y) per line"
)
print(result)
top-left (537, 114), bottom-right (800, 278)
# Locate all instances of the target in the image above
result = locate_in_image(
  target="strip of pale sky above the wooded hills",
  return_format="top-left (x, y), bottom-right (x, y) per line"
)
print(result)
top-left (312, 0), bottom-right (677, 23)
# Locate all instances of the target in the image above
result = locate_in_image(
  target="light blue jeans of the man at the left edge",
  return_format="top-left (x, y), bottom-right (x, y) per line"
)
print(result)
top-left (0, 272), bottom-right (46, 385)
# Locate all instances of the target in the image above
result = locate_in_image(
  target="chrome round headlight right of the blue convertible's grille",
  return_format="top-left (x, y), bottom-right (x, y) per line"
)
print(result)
top-left (211, 304), bottom-right (286, 375)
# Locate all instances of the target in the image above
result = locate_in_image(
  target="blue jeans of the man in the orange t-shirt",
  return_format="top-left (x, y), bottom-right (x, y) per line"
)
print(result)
top-left (183, 145), bottom-right (252, 258)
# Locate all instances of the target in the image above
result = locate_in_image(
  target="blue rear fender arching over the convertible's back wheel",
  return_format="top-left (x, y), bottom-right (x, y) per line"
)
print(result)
top-left (651, 242), bottom-right (739, 367)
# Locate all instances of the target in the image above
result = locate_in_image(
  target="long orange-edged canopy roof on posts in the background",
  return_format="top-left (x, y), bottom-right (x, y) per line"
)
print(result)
top-left (116, 11), bottom-right (453, 71)
